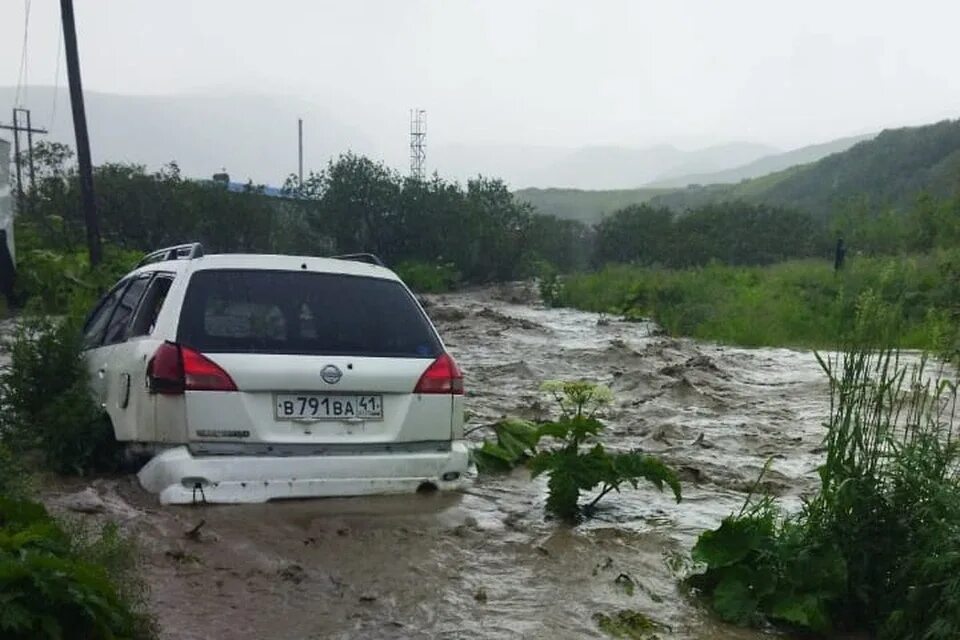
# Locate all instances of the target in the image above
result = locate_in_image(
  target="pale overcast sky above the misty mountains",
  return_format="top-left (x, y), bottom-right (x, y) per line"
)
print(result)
top-left (0, 0), bottom-right (960, 155)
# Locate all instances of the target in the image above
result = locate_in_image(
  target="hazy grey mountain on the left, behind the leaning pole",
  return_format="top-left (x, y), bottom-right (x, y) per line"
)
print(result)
top-left (0, 86), bottom-right (376, 186)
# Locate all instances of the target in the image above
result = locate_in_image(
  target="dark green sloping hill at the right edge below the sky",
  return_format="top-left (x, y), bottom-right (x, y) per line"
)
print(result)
top-left (651, 120), bottom-right (960, 217)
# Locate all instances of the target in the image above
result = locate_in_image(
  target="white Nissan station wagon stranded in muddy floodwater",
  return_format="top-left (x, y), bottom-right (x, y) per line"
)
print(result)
top-left (84, 244), bottom-right (469, 504)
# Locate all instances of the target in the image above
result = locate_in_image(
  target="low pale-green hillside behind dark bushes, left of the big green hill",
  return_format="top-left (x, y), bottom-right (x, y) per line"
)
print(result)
top-left (514, 189), bottom-right (670, 224)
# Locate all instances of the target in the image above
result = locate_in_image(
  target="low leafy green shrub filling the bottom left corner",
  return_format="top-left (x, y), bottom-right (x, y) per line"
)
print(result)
top-left (0, 497), bottom-right (154, 640)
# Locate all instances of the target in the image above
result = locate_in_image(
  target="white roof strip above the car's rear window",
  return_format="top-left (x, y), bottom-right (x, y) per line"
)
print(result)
top-left (130, 253), bottom-right (400, 280)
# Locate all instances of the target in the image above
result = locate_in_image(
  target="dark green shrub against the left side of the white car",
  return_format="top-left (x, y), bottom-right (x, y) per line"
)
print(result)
top-left (0, 316), bottom-right (119, 474)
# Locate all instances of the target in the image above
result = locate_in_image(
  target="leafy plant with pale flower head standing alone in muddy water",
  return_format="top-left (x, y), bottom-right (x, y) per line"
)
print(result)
top-left (528, 381), bottom-right (680, 522)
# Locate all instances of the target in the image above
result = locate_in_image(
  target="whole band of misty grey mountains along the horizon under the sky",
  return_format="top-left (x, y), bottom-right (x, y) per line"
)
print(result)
top-left (0, 86), bottom-right (868, 189)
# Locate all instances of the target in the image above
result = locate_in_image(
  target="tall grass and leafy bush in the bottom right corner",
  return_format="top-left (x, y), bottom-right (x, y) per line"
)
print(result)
top-left (691, 294), bottom-right (960, 640)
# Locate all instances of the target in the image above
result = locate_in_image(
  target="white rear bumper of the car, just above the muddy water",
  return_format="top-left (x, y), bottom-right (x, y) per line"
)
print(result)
top-left (137, 440), bottom-right (470, 504)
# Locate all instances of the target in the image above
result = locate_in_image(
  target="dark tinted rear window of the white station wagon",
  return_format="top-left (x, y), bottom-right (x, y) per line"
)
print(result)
top-left (177, 269), bottom-right (440, 358)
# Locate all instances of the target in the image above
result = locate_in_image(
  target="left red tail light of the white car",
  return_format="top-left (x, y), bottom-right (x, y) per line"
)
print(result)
top-left (147, 342), bottom-right (237, 394)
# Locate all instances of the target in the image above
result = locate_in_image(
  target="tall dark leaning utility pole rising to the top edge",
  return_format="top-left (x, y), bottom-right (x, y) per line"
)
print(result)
top-left (60, 0), bottom-right (103, 266)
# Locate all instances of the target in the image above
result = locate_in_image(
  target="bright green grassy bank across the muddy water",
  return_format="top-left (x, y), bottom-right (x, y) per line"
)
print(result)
top-left (552, 250), bottom-right (960, 348)
